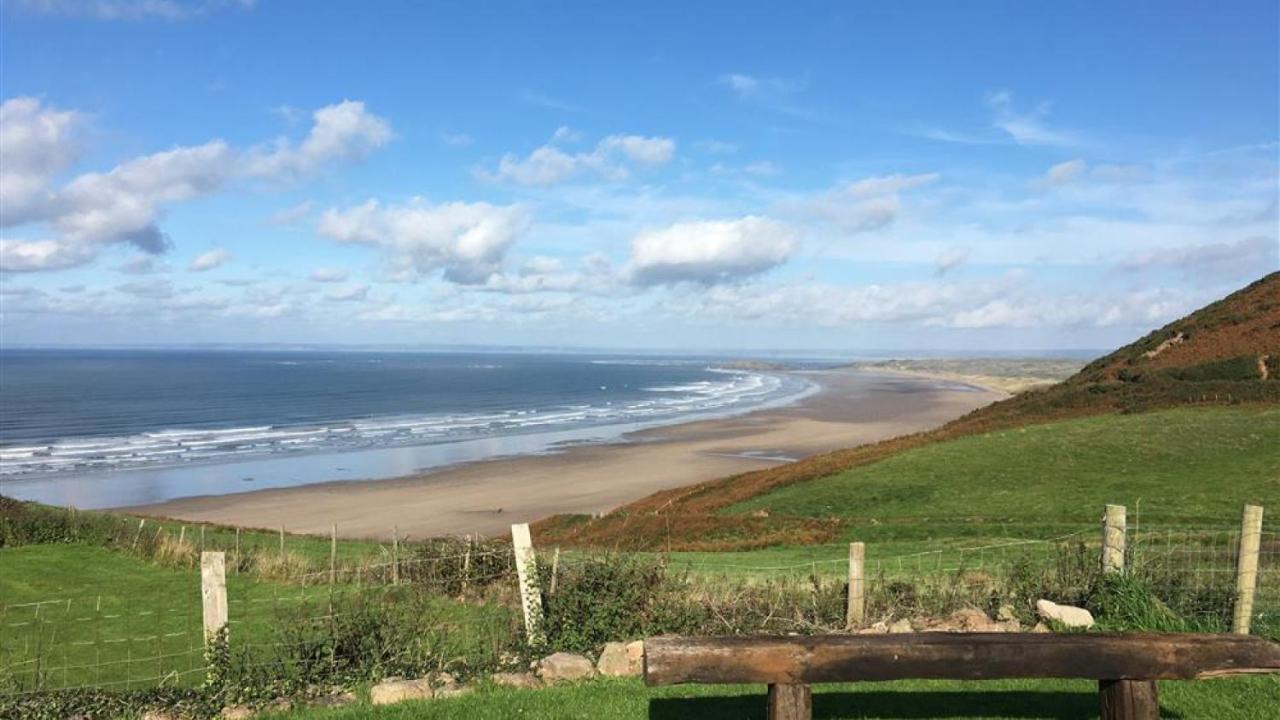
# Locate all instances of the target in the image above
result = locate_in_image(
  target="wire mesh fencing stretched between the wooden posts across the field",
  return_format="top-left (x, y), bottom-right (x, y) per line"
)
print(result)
top-left (0, 504), bottom-right (1280, 696)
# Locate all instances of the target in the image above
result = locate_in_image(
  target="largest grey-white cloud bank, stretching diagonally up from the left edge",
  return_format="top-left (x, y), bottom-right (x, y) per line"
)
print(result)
top-left (0, 97), bottom-right (390, 272)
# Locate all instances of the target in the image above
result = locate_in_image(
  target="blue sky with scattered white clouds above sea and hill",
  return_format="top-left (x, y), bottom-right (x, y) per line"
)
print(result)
top-left (0, 0), bottom-right (1280, 354)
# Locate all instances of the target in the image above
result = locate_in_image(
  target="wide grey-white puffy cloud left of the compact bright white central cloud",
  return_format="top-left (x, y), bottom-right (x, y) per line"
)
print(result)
top-left (316, 199), bottom-right (530, 284)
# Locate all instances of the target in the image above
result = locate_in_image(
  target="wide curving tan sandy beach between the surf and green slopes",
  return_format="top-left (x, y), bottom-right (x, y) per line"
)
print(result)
top-left (128, 369), bottom-right (1005, 538)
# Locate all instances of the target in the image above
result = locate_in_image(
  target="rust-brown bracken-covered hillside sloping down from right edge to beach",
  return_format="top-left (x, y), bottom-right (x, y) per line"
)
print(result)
top-left (535, 273), bottom-right (1280, 551)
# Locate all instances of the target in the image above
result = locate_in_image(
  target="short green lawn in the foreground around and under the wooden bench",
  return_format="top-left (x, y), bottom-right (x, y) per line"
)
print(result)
top-left (262, 678), bottom-right (1280, 720)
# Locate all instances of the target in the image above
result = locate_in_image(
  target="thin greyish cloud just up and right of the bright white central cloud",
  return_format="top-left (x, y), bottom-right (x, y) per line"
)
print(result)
top-left (785, 173), bottom-right (938, 233)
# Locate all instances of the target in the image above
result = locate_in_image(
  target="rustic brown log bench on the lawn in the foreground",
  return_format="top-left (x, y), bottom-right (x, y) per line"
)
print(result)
top-left (644, 633), bottom-right (1280, 720)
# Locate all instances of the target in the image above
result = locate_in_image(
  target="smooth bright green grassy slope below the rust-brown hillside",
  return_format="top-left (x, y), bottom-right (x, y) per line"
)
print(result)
top-left (728, 407), bottom-right (1280, 537)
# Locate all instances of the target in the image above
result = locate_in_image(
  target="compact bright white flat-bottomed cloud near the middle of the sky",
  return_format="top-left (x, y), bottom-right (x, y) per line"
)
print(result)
top-left (628, 215), bottom-right (799, 286)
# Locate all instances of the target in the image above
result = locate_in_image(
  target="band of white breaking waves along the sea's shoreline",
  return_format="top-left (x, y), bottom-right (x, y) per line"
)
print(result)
top-left (0, 370), bottom-right (805, 477)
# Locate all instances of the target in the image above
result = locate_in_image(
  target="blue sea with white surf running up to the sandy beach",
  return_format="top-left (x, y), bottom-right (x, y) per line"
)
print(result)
top-left (0, 348), bottom-right (815, 509)
